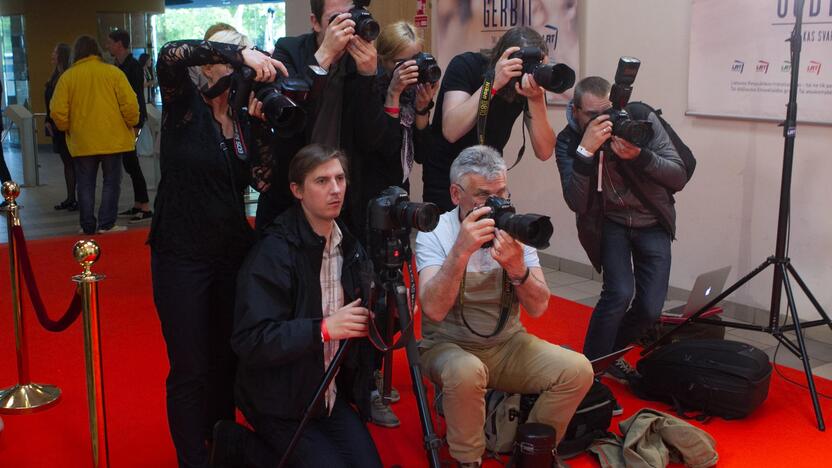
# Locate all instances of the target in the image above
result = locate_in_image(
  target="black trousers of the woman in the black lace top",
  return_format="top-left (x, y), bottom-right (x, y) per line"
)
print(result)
top-left (151, 252), bottom-right (241, 468)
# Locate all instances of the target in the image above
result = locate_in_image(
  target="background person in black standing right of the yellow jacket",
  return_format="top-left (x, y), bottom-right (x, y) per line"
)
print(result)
top-left (106, 29), bottom-right (153, 224)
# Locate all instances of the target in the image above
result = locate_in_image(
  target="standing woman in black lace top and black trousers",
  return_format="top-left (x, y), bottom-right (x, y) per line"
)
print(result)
top-left (148, 25), bottom-right (286, 467)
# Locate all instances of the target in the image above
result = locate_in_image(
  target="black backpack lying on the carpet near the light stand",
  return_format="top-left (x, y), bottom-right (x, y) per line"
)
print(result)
top-left (630, 340), bottom-right (772, 420)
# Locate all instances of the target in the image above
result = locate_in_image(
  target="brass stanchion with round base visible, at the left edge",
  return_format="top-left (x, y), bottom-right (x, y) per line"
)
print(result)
top-left (0, 182), bottom-right (61, 414)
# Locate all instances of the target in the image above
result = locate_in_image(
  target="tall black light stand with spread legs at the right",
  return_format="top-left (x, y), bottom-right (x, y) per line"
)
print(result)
top-left (641, 0), bottom-right (832, 431)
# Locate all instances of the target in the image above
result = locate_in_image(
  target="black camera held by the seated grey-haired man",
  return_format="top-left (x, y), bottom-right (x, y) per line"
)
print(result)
top-left (481, 195), bottom-right (555, 249)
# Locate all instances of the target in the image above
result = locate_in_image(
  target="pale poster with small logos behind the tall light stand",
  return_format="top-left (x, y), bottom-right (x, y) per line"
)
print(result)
top-left (688, 0), bottom-right (832, 124)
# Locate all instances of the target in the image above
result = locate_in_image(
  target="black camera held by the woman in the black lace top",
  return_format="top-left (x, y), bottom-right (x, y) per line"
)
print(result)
top-left (229, 66), bottom-right (310, 137)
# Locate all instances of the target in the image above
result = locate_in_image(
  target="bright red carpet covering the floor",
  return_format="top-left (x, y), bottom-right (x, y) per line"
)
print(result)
top-left (0, 230), bottom-right (832, 468)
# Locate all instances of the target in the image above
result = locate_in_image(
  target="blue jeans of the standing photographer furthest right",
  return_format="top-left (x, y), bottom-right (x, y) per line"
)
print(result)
top-left (584, 220), bottom-right (671, 360)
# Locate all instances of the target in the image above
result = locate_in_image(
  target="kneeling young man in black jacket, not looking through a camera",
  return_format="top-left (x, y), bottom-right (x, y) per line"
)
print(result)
top-left (212, 144), bottom-right (381, 467)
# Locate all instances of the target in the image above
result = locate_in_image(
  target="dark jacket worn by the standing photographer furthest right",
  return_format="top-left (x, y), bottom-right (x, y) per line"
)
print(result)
top-left (555, 104), bottom-right (687, 272)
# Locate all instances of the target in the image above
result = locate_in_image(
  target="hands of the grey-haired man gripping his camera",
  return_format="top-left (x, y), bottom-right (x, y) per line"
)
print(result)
top-left (456, 206), bottom-right (525, 277)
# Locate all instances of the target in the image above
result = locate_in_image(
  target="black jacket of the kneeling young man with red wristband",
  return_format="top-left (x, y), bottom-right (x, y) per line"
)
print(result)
top-left (231, 204), bottom-right (374, 419)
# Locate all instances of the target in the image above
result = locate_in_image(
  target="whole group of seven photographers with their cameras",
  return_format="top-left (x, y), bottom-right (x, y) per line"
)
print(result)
top-left (135, 0), bottom-right (686, 467)
